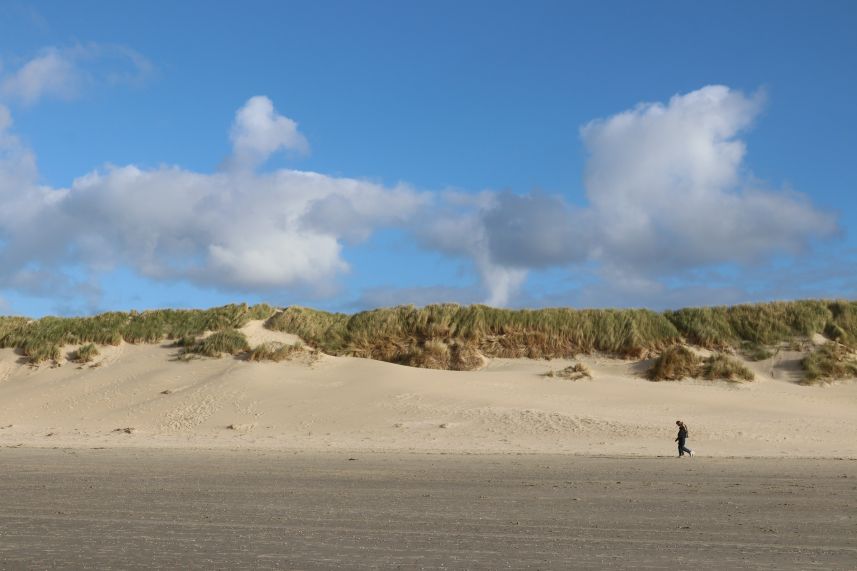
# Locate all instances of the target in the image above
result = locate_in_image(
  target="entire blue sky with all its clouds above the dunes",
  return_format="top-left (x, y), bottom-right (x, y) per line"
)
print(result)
top-left (0, 0), bottom-right (857, 317)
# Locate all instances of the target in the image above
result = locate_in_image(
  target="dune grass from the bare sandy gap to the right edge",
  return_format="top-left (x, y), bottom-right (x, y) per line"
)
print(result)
top-left (266, 300), bottom-right (857, 369)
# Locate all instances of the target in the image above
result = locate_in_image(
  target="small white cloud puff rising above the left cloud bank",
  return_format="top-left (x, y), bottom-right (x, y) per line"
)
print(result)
top-left (229, 95), bottom-right (309, 169)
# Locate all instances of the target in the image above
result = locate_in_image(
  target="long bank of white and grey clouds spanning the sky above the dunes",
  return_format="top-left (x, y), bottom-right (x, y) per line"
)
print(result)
top-left (0, 84), bottom-right (836, 312)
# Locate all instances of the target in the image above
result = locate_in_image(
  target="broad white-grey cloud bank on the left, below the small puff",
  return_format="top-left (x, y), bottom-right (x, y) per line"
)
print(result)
top-left (0, 98), bottom-right (426, 302)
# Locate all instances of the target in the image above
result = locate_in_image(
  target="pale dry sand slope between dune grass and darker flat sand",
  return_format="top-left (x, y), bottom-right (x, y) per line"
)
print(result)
top-left (0, 322), bottom-right (857, 458)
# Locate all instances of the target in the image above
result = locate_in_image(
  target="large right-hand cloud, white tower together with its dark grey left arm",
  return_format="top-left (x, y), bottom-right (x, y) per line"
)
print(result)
top-left (420, 85), bottom-right (837, 303)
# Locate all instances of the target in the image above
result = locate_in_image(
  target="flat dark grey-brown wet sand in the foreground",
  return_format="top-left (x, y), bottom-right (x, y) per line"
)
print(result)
top-left (0, 448), bottom-right (857, 569)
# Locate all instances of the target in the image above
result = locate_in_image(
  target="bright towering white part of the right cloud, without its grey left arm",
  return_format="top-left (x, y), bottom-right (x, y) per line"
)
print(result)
top-left (581, 85), bottom-right (836, 272)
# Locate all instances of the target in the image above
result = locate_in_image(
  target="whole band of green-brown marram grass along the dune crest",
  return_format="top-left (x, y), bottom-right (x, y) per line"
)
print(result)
top-left (5, 300), bottom-right (857, 384)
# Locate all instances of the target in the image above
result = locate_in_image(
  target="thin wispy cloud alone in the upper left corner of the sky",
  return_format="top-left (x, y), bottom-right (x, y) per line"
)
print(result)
top-left (0, 44), bottom-right (153, 105)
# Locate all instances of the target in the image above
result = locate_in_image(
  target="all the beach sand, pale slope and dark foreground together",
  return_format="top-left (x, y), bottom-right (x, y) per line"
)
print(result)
top-left (0, 322), bottom-right (857, 569)
